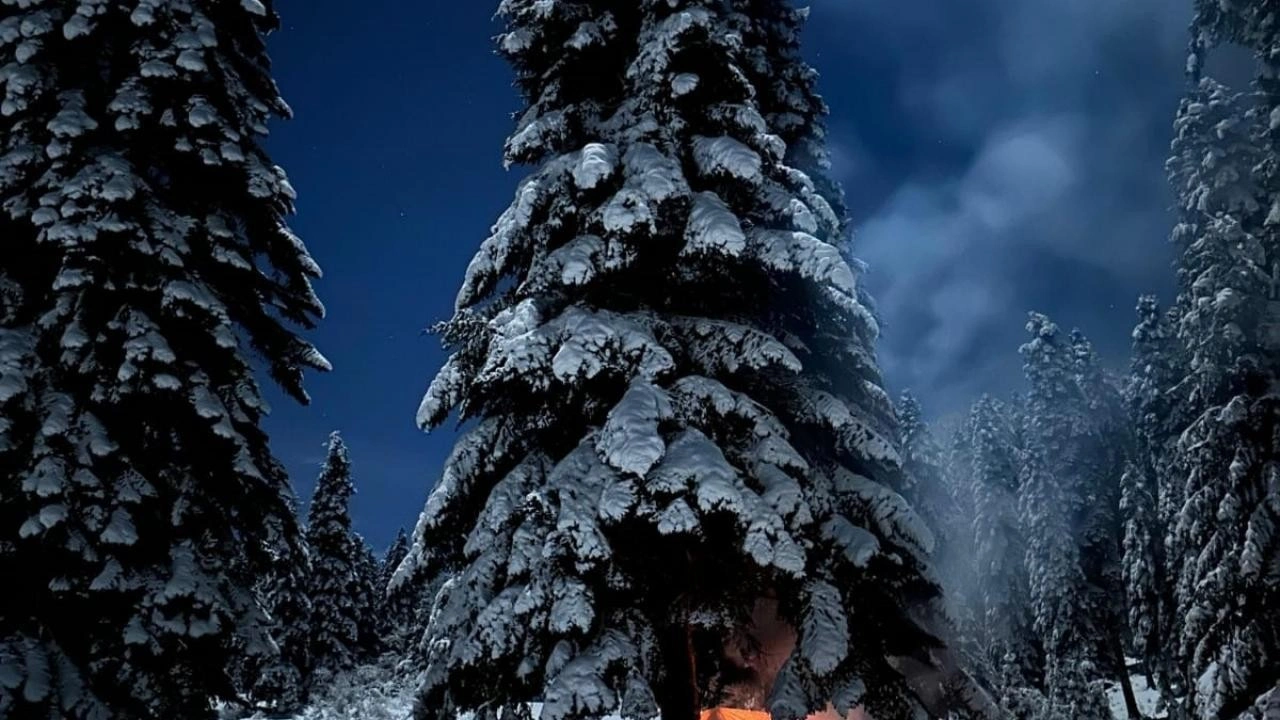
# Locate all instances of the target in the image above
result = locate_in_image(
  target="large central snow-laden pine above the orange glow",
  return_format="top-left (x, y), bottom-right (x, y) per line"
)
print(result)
top-left (398, 0), bottom-right (952, 720)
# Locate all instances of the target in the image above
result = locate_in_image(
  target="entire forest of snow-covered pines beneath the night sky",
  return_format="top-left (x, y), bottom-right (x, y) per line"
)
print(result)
top-left (0, 0), bottom-right (1280, 720)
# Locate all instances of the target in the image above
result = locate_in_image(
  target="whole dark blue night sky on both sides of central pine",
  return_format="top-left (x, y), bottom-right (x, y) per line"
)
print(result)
top-left (257, 0), bottom-right (1190, 548)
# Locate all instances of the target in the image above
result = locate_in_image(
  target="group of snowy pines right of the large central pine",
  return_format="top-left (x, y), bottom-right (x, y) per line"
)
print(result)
top-left (900, 3), bottom-right (1280, 719)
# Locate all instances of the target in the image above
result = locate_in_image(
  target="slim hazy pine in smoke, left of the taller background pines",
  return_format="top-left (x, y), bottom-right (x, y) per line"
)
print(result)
top-left (957, 396), bottom-right (1044, 694)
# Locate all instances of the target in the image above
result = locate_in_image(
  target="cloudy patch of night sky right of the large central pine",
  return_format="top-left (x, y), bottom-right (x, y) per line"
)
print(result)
top-left (810, 0), bottom-right (1190, 414)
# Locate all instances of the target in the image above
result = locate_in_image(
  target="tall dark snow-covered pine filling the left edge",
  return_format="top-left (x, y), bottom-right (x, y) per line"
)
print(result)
top-left (0, 0), bottom-right (328, 719)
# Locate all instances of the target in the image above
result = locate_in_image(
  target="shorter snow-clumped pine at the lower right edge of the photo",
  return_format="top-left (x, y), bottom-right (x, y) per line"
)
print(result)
top-left (1170, 395), bottom-right (1280, 717)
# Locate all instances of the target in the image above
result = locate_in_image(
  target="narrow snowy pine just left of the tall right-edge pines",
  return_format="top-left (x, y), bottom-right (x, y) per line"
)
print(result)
top-left (1120, 295), bottom-right (1185, 697)
